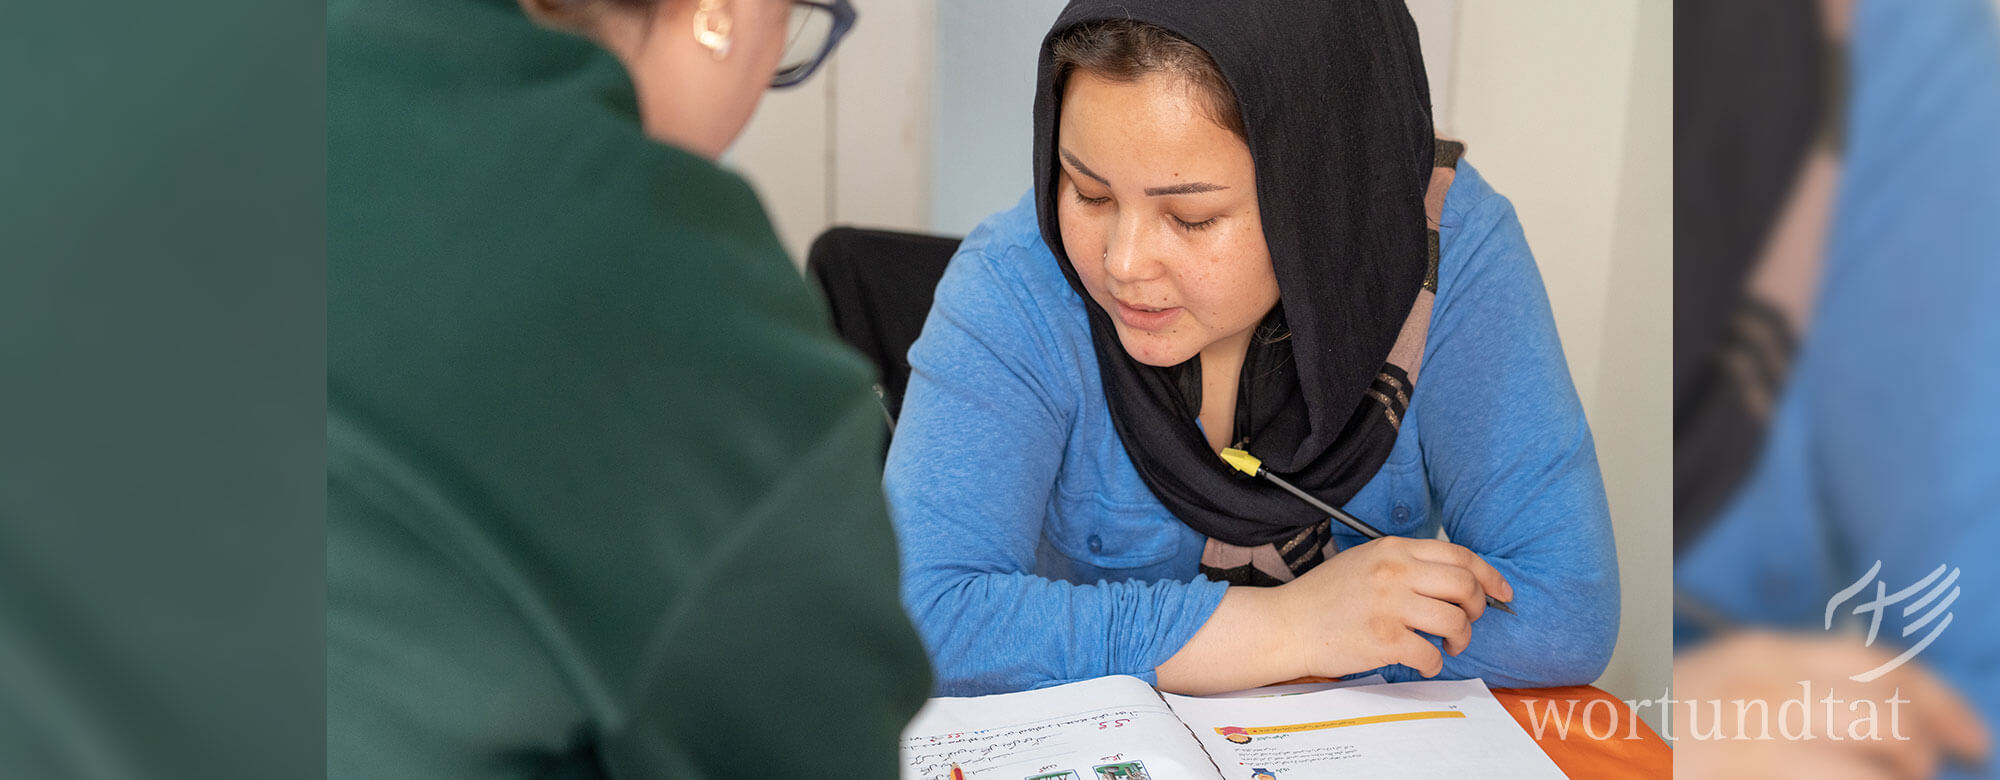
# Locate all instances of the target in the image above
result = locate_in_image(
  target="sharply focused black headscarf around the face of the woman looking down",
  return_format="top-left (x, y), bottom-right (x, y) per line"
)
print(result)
top-left (1034, 0), bottom-right (1434, 546)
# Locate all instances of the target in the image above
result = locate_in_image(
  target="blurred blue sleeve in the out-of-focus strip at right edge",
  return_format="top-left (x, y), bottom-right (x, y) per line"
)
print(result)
top-left (1674, 0), bottom-right (2000, 778)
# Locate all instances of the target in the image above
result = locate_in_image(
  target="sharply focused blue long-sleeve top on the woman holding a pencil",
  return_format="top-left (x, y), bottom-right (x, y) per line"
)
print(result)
top-left (886, 164), bottom-right (1618, 696)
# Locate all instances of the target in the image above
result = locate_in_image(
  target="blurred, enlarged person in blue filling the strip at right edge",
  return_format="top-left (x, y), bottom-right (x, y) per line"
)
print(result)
top-left (1674, 0), bottom-right (2000, 780)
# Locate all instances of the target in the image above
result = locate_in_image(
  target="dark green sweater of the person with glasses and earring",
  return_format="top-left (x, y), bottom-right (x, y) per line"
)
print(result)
top-left (326, 0), bottom-right (930, 778)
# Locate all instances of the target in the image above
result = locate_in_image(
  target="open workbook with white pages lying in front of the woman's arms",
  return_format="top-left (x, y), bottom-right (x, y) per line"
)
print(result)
top-left (902, 676), bottom-right (1562, 780)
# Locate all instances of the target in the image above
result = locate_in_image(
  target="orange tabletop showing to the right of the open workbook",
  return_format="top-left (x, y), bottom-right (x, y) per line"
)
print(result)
top-left (1494, 686), bottom-right (1674, 780)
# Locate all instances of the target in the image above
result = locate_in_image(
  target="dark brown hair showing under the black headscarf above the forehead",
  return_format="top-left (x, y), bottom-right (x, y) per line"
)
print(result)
top-left (1048, 20), bottom-right (1248, 138)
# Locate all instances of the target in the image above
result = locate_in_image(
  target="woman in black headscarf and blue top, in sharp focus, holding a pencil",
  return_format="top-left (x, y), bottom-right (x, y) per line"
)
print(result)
top-left (888, 0), bottom-right (1618, 694)
